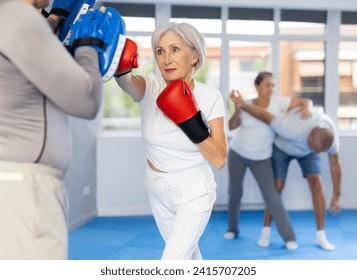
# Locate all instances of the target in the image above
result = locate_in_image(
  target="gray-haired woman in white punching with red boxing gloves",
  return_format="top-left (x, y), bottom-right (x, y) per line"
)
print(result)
top-left (116, 22), bottom-right (227, 259)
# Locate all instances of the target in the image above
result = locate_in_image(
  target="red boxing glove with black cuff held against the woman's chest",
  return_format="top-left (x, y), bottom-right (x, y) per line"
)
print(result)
top-left (156, 80), bottom-right (209, 144)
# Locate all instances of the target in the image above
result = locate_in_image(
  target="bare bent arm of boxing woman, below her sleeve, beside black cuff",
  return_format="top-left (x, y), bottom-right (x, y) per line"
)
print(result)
top-left (197, 117), bottom-right (228, 169)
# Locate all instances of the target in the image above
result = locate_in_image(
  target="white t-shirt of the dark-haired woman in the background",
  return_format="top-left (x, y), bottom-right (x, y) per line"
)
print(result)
top-left (229, 96), bottom-right (291, 160)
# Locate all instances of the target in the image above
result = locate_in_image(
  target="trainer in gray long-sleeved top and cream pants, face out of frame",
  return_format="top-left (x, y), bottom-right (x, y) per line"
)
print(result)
top-left (0, 0), bottom-right (122, 260)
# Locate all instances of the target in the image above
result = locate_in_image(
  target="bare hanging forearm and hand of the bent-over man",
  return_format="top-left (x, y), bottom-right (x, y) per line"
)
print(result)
top-left (328, 153), bottom-right (342, 215)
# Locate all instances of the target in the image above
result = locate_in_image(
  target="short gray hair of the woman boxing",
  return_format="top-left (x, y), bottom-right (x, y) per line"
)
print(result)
top-left (151, 22), bottom-right (206, 71)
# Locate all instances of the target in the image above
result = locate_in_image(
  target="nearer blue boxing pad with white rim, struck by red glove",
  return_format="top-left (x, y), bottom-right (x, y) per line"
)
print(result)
top-left (69, 8), bottom-right (126, 82)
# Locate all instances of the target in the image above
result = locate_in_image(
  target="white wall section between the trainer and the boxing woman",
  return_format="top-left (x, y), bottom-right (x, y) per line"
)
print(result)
top-left (97, 132), bottom-right (151, 216)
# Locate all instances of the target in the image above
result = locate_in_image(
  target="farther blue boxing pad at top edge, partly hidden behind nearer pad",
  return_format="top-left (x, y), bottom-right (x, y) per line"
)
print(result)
top-left (58, 0), bottom-right (97, 46)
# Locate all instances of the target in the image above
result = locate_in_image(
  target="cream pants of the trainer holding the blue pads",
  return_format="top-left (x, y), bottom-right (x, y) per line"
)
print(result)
top-left (0, 162), bottom-right (68, 260)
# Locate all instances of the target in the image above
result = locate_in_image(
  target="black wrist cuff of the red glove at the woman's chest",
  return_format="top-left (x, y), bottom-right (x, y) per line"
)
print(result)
top-left (178, 111), bottom-right (209, 144)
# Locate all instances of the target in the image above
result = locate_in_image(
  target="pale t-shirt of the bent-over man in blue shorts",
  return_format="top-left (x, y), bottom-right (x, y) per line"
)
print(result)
top-left (271, 109), bottom-right (340, 157)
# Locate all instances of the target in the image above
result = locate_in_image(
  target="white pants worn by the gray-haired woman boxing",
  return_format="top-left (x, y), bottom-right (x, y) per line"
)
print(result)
top-left (145, 165), bottom-right (216, 260)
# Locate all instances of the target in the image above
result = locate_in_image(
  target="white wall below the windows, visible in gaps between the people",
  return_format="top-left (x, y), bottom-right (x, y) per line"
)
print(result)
top-left (97, 134), bottom-right (357, 216)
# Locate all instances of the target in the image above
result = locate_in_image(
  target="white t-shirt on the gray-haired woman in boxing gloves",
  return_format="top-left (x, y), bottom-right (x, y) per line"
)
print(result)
top-left (139, 74), bottom-right (225, 172)
